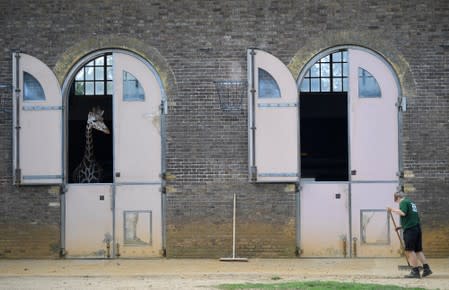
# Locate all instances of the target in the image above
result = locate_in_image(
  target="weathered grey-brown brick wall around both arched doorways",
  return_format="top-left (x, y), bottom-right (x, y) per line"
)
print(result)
top-left (0, 0), bottom-right (449, 257)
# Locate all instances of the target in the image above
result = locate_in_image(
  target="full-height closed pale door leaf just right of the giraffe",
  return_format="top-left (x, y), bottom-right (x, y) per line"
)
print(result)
top-left (113, 53), bottom-right (162, 257)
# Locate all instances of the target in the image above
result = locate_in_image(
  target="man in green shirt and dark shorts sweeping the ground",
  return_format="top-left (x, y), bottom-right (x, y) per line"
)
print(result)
top-left (387, 192), bottom-right (432, 278)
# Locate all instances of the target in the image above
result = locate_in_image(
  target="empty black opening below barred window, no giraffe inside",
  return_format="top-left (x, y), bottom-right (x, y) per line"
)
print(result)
top-left (300, 92), bottom-right (349, 181)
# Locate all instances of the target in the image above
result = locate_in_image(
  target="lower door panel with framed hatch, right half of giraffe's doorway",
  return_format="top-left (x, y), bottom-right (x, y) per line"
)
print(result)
top-left (115, 184), bottom-right (162, 258)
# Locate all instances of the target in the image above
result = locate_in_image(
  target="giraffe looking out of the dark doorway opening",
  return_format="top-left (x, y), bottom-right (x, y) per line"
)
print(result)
top-left (73, 107), bottom-right (109, 183)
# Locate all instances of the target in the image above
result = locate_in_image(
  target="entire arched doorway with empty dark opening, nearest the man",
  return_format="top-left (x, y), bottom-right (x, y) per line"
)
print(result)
top-left (298, 47), bottom-right (400, 257)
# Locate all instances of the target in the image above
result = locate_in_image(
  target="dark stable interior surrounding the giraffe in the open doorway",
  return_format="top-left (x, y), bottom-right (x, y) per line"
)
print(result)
top-left (68, 85), bottom-right (113, 183)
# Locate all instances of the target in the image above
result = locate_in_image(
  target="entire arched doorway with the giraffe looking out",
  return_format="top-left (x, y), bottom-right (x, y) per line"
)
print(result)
top-left (63, 49), bottom-right (165, 258)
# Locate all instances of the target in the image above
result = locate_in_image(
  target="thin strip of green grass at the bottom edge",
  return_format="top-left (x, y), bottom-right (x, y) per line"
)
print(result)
top-left (218, 281), bottom-right (424, 290)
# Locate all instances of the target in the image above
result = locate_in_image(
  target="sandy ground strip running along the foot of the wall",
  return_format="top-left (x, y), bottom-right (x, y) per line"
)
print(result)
top-left (0, 258), bottom-right (449, 289)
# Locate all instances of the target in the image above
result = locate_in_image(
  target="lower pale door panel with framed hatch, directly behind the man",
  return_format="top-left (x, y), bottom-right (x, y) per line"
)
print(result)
top-left (351, 183), bottom-right (400, 257)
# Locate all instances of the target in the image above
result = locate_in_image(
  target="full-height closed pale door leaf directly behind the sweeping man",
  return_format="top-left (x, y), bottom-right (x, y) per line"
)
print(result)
top-left (349, 49), bottom-right (399, 257)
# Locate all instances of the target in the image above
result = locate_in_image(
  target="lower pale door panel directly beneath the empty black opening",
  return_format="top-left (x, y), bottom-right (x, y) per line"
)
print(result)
top-left (300, 183), bottom-right (349, 257)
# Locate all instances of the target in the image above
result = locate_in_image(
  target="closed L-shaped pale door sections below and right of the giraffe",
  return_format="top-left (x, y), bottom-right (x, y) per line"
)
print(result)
top-left (65, 52), bottom-right (162, 258)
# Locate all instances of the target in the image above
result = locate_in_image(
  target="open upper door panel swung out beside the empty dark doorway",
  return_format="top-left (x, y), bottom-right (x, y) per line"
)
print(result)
top-left (248, 49), bottom-right (299, 182)
